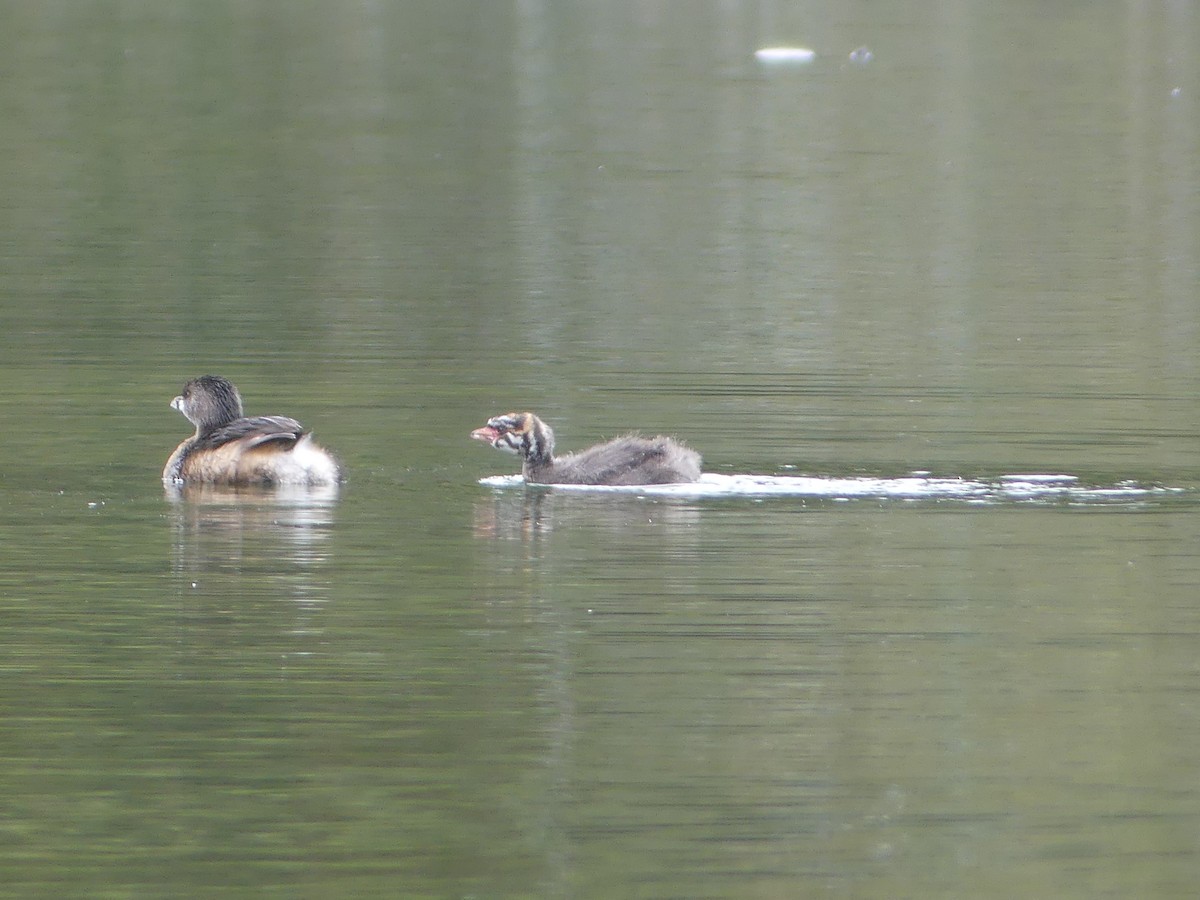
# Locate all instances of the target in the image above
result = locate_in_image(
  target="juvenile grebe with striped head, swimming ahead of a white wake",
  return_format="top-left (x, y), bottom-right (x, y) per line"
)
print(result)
top-left (470, 413), bottom-right (700, 485)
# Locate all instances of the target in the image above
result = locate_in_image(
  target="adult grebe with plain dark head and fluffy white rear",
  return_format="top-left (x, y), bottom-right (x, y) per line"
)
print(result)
top-left (162, 376), bottom-right (340, 485)
